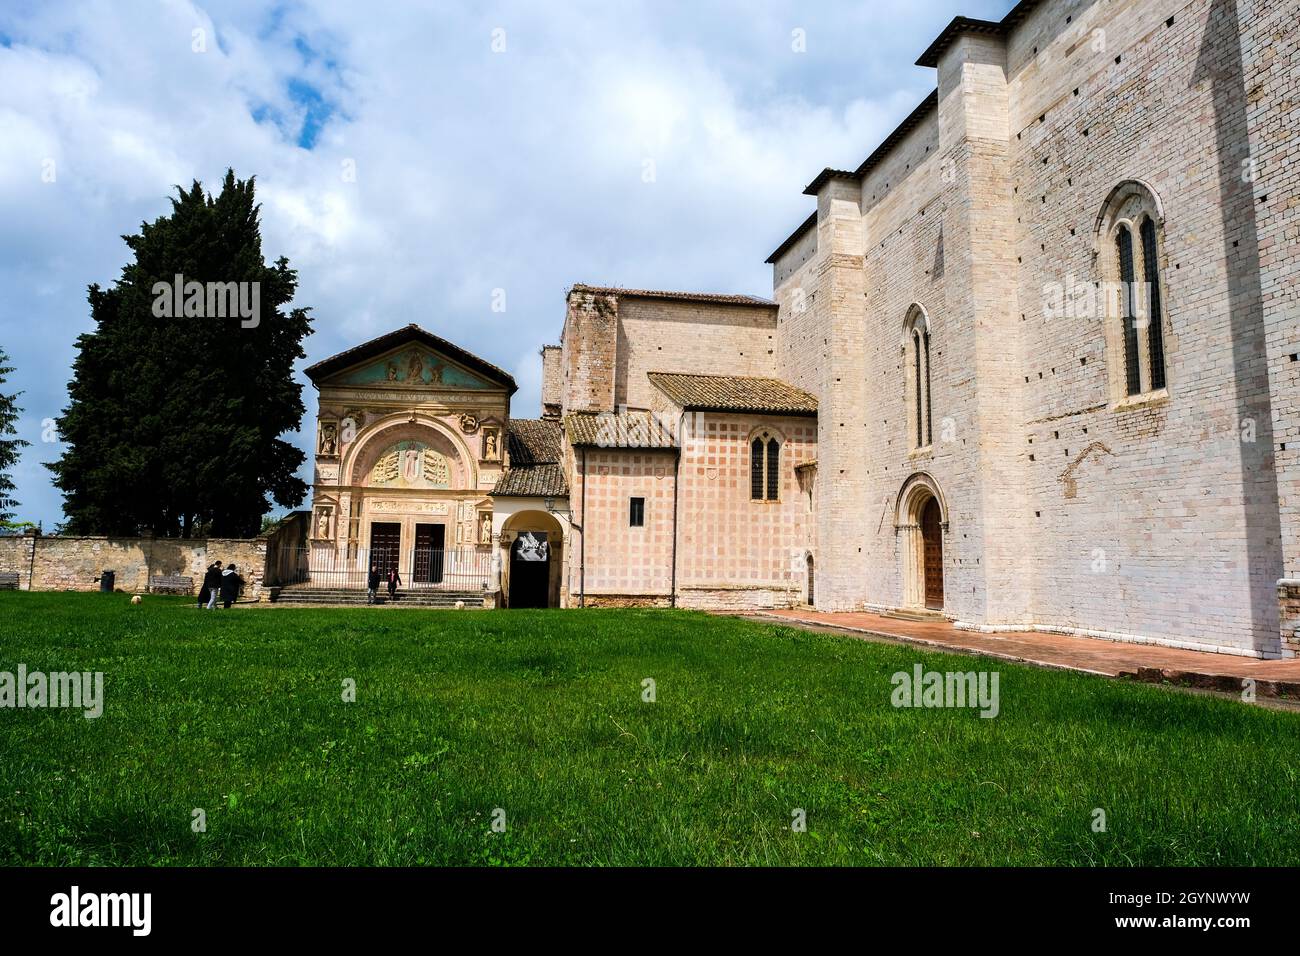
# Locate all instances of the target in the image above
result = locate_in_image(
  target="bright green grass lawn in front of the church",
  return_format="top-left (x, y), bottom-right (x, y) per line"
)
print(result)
top-left (0, 593), bottom-right (1300, 865)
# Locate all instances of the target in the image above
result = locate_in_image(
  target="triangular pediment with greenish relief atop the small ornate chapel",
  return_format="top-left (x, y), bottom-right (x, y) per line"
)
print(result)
top-left (307, 325), bottom-right (517, 394)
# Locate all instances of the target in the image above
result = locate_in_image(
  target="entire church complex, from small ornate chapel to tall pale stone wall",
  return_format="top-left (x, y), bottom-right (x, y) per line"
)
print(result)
top-left (309, 0), bottom-right (1300, 657)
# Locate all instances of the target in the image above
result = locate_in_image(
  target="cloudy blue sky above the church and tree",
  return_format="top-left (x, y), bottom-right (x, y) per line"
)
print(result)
top-left (0, 0), bottom-right (1013, 529)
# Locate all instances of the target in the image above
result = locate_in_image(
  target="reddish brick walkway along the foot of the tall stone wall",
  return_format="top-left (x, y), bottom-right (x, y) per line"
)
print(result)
top-left (749, 609), bottom-right (1300, 697)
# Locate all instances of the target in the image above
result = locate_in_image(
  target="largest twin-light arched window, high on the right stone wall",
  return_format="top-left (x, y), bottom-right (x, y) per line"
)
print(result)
top-left (1097, 179), bottom-right (1167, 401)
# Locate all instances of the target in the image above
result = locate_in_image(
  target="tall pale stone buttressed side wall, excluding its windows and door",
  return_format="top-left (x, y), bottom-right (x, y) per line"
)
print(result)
top-left (774, 0), bottom-right (1300, 656)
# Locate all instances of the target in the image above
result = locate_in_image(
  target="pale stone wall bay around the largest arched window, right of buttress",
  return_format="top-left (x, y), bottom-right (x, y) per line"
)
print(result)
top-left (1009, 0), bottom-right (1282, 654)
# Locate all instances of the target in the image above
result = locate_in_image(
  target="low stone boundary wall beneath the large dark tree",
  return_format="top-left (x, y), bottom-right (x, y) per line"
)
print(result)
top-left (0, 512), bottom-right (307, 601)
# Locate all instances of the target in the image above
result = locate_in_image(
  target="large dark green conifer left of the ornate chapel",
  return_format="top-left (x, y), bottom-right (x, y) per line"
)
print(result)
top-left (48, 170), bottom-right (311, 537)
